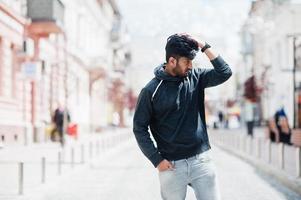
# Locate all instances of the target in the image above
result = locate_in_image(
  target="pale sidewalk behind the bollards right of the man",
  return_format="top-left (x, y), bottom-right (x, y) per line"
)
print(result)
top-left (209, 129), bottom-right (301, 195)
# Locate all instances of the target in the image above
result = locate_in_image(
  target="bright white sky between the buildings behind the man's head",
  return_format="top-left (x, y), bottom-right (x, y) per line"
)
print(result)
top-left (116, 0), bottom-right (251, 93)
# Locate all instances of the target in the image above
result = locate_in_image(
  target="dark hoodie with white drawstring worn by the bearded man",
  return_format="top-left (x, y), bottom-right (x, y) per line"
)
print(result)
top-left (133, 56), bottom-right (232, 167)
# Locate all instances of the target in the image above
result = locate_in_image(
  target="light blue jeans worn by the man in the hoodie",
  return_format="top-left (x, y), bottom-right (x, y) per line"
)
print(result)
top-left (159, 151), bottom-right (220, 200)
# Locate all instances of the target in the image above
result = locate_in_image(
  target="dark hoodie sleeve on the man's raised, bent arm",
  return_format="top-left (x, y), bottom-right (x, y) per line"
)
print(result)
top-left (200, 56), bottom-right (232, 88)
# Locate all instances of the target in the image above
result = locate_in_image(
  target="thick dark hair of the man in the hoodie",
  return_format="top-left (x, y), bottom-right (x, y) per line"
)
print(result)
top-left (165, 34), bottom-right (199, 62)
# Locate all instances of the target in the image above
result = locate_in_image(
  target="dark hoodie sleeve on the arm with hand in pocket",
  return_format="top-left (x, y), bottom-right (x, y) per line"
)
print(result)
top-left (133, 88), bottom-right (163, 167)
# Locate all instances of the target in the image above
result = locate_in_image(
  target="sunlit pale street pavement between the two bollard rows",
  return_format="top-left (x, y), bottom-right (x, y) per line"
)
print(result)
top-left (5, 134), bottom-right (300, 200)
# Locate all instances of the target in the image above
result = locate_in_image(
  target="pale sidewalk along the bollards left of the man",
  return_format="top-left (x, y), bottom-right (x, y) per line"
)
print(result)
top-left (0, 129), bottom-right (129, 199)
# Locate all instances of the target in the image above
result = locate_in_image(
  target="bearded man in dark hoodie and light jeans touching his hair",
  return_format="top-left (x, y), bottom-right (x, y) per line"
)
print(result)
top-left (133, 34), bottom-right (232, 200)
